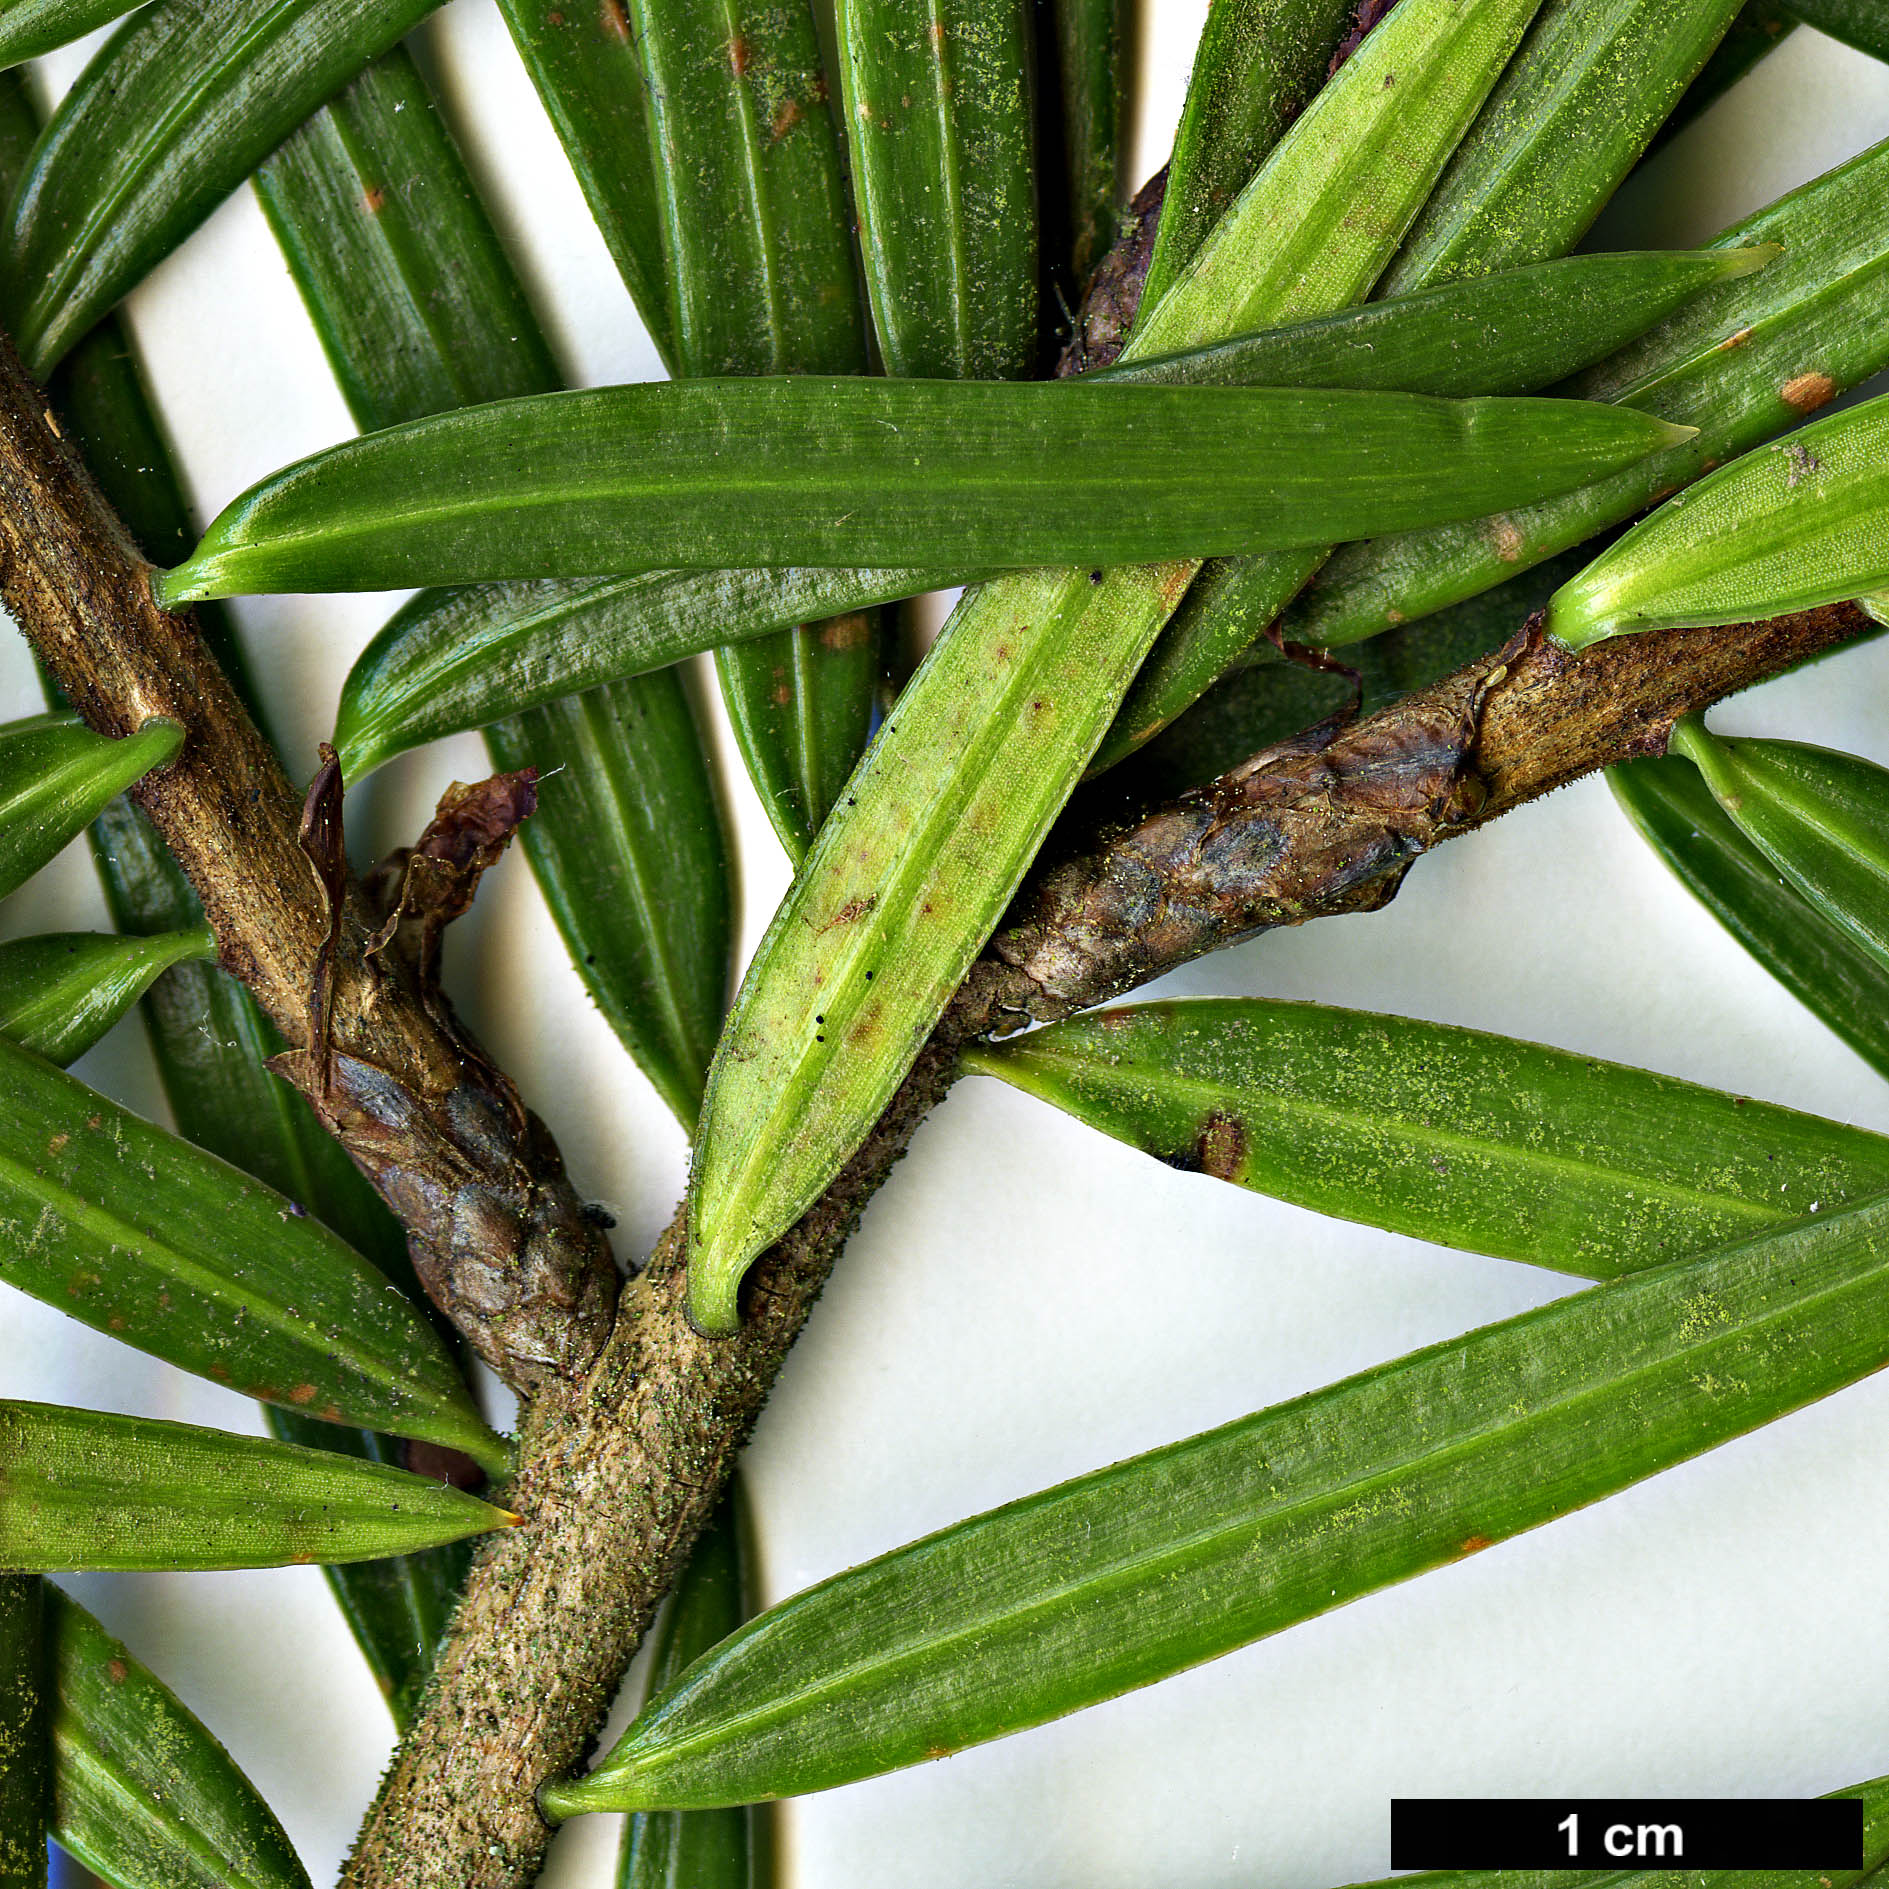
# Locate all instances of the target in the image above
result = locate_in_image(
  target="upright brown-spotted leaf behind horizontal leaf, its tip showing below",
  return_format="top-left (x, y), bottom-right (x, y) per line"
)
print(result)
top-left (612, 0), bottom-right (880, 859)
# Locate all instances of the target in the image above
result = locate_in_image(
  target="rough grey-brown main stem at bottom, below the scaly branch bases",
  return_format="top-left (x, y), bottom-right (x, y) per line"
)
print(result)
top-left (342, 1030), bottom-right (963, 1889)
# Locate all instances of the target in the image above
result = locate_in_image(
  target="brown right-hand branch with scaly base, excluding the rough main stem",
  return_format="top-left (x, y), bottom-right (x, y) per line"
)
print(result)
top-left (988, 604), bottom-right (1870, 1028)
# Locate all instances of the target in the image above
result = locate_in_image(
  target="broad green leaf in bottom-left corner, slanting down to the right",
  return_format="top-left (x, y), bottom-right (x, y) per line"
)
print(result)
top-left (45, 1585), bottom-right (308, 1889)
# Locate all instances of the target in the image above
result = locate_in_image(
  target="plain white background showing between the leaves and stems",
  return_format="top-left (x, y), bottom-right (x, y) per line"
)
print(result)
top-left (11, 0), bottom-right (1889, 1889)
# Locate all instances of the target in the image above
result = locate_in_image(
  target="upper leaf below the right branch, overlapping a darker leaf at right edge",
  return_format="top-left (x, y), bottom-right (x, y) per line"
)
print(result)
top-left (1672, 716), bottom-right (1889, 973)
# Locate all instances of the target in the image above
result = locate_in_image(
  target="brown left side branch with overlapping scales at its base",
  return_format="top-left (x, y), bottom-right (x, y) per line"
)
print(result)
top-left (0, 338), bottom-right (616, 1390)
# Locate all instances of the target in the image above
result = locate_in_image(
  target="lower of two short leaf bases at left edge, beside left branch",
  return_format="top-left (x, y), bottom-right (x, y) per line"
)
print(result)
top-left (0, 926), bottom-right (217, 1067)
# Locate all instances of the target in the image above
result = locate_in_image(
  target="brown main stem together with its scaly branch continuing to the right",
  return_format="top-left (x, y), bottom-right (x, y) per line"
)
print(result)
top-left (344, 606), bottom-right (1868, 1889)
